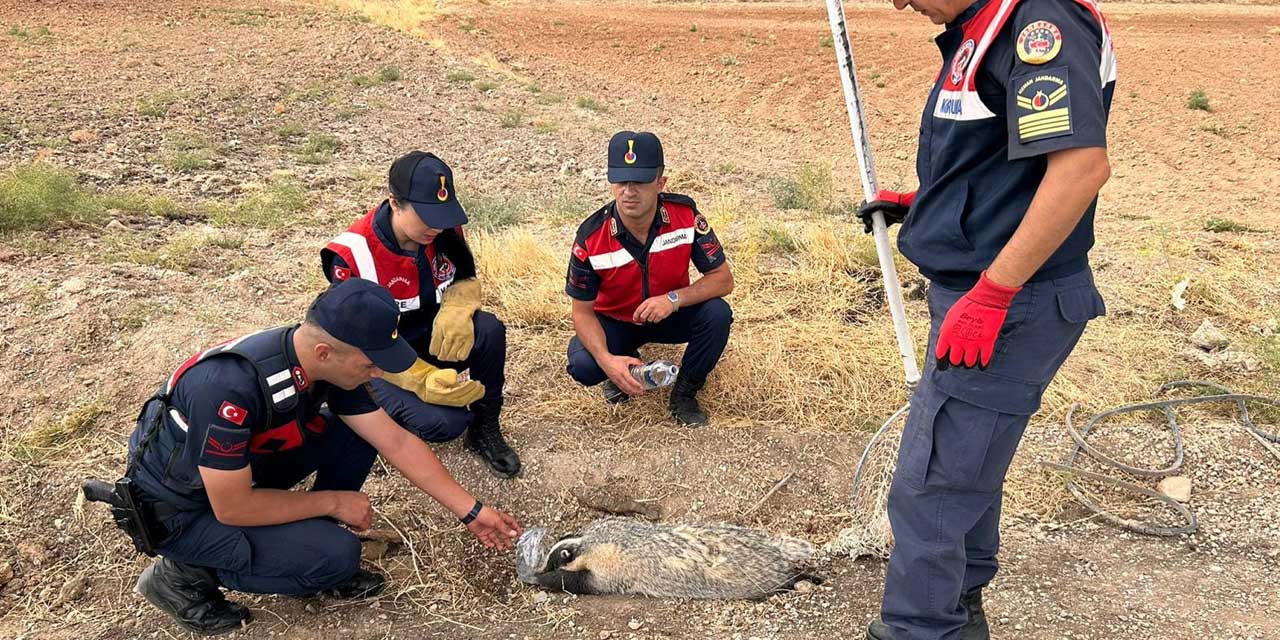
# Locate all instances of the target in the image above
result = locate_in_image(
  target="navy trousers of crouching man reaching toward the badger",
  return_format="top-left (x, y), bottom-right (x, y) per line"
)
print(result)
top-left (156, 412), bottom-right (378, 595)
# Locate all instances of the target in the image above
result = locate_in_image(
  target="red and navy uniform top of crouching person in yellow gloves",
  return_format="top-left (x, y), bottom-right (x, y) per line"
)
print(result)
top-left (320, 201), bottom-right (475, 342)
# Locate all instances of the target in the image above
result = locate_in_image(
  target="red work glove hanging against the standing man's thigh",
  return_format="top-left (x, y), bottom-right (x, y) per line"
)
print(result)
top-left (933, 271), bottom-right (1023, 369)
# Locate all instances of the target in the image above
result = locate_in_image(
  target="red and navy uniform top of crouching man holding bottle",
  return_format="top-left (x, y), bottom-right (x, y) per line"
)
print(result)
top-left (564, 193), bottom-right (724, 323)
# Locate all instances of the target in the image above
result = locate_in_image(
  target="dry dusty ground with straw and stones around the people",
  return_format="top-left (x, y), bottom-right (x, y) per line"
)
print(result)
top-left (0, 0), bottom-right (1280, 640)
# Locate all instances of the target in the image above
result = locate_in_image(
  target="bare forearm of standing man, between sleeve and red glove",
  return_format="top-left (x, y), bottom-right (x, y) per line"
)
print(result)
top-left (987, 147), bottom-right (1111, 287)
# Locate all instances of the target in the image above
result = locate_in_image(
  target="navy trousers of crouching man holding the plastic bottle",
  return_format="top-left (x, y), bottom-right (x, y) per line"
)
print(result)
top-left (568, 298), bottom-right (733, 387)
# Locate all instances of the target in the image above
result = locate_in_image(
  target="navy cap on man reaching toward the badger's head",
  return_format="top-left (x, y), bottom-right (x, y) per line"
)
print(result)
top-left (307, 278), bottom-right (417, 374)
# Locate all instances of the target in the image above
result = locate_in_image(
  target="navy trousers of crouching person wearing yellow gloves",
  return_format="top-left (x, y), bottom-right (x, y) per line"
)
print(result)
top-left (370, 311), bottom-right (507, 442)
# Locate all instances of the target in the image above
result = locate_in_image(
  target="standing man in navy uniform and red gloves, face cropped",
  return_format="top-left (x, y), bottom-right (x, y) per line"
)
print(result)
top-left (861, 0), bottom-right (1116, 640)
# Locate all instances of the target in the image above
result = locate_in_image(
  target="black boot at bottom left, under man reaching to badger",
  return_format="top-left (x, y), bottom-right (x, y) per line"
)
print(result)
top-left (133, 558), bottom-right (252, 636)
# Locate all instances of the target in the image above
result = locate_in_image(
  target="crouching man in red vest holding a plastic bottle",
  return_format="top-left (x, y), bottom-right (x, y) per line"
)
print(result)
top-left (564, 131), bottom-right (733, 426)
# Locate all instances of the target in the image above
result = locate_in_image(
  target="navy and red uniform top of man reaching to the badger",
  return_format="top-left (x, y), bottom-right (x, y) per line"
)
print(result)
top-left (129, 326), bottom-right (332, 508)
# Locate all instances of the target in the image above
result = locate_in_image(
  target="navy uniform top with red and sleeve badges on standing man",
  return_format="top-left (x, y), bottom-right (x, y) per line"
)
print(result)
top-left (899, 0), bottom-right (1116, 289)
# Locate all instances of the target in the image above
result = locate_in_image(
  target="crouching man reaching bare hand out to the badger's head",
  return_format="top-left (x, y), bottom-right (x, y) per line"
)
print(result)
top-left (125, 279), bottom-right (520, 634)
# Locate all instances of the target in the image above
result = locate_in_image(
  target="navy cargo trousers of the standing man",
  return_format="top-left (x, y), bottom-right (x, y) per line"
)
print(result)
top-left (881, 270), bottom-right (1106, 640)
